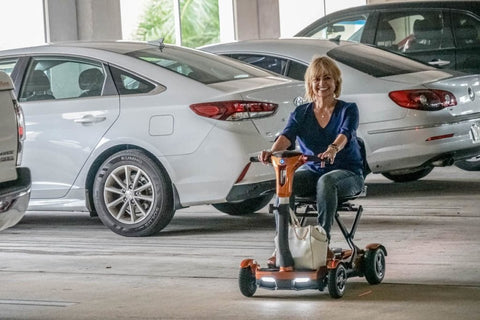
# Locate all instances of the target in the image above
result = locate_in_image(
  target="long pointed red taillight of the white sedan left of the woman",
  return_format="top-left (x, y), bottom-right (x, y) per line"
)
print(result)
top-left (190, 100), bottom-right (278, 121)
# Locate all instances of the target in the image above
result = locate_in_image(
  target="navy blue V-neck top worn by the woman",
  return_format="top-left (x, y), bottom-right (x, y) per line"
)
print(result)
top-left (281, 100), bottom-right (363, 174)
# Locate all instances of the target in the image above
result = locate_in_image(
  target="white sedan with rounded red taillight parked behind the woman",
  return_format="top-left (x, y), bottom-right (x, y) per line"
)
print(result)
top-left (203, 38), bottom-right (480, 178)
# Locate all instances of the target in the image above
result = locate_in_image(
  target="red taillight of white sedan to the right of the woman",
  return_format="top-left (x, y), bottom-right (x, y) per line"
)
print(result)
top-left (388, 89), bottom-right (457, 111)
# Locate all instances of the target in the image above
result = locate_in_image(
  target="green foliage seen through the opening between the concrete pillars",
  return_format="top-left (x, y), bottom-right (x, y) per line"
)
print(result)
top-left (137, 0), bottom-right (220, 48)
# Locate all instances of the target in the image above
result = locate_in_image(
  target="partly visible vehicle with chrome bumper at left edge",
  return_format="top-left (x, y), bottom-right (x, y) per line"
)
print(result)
top-left (0, 71), bottom-right (31, 230)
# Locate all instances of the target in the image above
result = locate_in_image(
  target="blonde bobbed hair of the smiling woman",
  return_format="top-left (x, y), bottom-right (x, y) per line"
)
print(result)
top-left (305, 56), bottom-right (342, 102)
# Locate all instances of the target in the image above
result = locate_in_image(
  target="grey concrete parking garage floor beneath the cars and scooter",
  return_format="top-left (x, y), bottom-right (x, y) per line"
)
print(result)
top-left (0, 167), bottom-right (480, 320)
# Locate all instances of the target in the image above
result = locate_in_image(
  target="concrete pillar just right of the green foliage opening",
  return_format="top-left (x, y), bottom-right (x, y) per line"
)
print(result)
top-left (234, 0), bottom-right (280, 40)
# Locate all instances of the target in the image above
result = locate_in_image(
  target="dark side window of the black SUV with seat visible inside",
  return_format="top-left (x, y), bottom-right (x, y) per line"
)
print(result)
top-left (374, 10), bottom-right (453, 52)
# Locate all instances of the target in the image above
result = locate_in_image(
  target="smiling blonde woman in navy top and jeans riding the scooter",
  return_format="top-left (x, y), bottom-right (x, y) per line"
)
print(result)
top-left (259, 57), bottom-right (364, 239)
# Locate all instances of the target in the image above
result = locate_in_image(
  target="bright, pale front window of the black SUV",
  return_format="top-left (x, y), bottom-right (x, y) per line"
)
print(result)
top-left (305, 13), bottom-right (368, 42)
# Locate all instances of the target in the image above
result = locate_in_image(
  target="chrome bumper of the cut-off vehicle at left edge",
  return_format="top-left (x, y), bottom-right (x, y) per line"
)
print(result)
top-left (0, 168), bottom-right (32, 230)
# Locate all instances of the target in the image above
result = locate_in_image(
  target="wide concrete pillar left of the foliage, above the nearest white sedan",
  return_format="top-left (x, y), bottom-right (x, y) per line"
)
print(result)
top-left (44, 0), bottom-right (122, 42)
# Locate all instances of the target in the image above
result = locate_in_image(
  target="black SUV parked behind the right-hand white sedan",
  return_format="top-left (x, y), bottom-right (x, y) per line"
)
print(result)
top-left (296, 1), bottom-right (480, 73)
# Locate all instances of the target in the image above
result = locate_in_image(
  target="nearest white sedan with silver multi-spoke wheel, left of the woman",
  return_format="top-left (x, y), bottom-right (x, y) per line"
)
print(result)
top-left (0, 42), bottom-right (304, 236)
